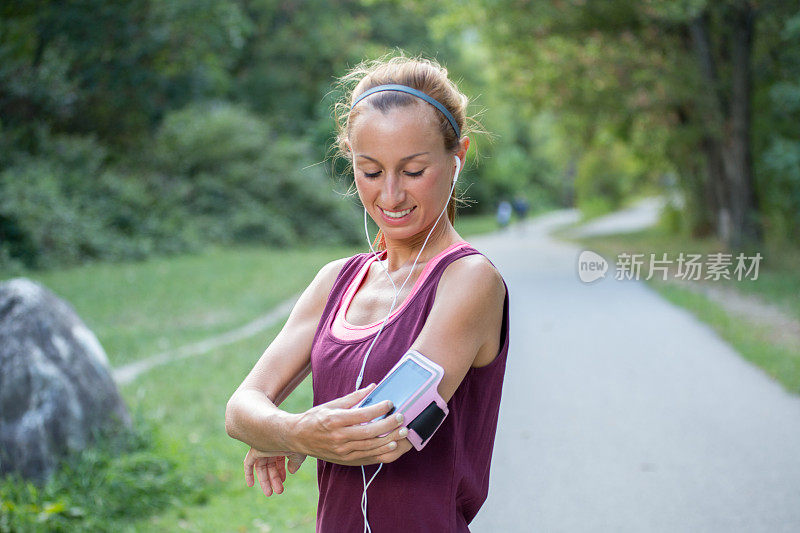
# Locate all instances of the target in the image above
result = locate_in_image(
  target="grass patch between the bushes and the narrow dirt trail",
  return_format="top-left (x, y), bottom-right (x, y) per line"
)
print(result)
top-left (14, 247), bottom-right (353, 366)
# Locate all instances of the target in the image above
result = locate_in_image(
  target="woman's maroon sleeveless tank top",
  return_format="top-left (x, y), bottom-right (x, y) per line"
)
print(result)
top-left (311, 245), bottom-right (509, 533)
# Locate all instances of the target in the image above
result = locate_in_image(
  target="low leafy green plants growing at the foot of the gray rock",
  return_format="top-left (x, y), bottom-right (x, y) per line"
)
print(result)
top-left (0, 416), bottom-right (207, 532)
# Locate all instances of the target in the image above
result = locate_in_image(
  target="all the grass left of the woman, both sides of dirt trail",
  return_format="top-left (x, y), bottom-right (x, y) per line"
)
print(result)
top-left (0, 243), bottom-right (350, 531)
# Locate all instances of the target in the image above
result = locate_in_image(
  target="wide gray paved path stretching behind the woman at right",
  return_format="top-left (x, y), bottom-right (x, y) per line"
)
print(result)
top-left (470, 211), bottom-right (800, 533)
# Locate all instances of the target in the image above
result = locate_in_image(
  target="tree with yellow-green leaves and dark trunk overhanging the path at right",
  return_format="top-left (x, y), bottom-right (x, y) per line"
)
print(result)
top-left (460, 0), bottom-right (797, 247)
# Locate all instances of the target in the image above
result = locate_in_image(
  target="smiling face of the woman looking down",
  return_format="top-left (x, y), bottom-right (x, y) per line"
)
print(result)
top-left (349, 103), bottom-right (462, 244)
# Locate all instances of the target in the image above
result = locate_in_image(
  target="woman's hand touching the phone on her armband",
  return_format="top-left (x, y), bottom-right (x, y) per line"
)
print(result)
top-left (294, 383), bottom-right (411, 466)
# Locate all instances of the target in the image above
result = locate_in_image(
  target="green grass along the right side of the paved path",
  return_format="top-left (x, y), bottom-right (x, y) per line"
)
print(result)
top-left (560, 227), bottom-right (800, 394)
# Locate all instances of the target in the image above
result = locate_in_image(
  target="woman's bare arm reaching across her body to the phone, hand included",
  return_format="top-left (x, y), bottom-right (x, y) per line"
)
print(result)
top-left (225, 259), bottom-right (406, 471)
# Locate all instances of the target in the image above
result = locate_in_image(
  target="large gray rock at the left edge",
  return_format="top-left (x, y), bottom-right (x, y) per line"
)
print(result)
top-left (0, 278), bottom-right (130, 481)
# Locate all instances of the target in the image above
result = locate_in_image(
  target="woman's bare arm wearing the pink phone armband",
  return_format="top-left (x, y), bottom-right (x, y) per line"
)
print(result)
top-left (370, 254), bottom-right (506, 463)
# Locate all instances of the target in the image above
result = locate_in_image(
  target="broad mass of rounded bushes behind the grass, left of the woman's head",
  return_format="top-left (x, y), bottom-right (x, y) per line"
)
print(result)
top-left (0, 103), bottom-right (360, 270)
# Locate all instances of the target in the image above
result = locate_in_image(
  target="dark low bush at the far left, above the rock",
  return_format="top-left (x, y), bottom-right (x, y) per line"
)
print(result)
top-left (0, 158), bottom-right (199, 267)
